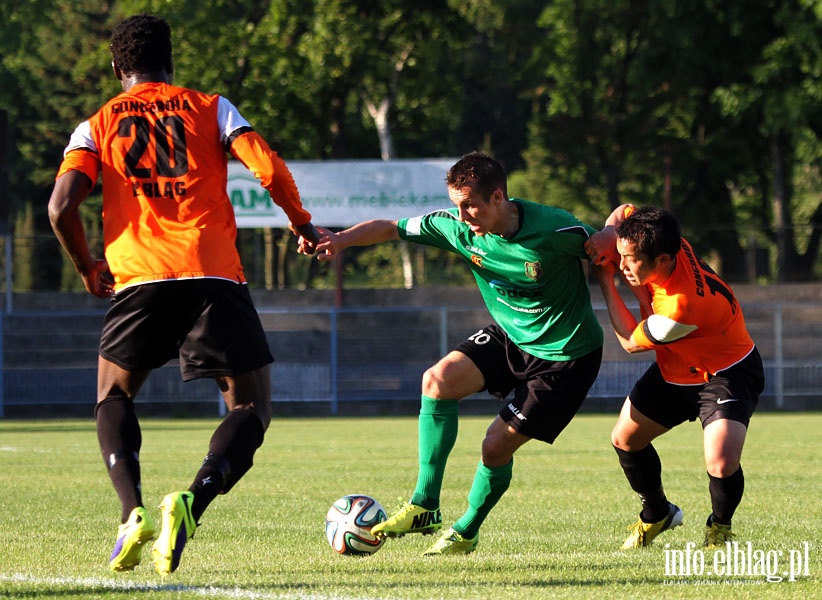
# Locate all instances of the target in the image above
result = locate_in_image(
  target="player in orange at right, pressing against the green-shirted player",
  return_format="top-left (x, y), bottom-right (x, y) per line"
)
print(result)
top-left (587, 205), bottom-right (765, 549)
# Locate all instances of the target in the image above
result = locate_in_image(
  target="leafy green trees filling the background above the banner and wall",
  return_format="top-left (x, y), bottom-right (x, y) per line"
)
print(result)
top-left (0, 0), bottom-right (822, 291)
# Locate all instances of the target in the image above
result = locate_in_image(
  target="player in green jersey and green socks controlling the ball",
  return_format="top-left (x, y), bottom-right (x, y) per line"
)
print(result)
top-left (304, 152), bottom-right (603, 555)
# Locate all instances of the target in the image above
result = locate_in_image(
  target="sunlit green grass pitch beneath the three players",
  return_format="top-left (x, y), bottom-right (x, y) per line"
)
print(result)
top-left (0, 414), bottom-right (822, 600)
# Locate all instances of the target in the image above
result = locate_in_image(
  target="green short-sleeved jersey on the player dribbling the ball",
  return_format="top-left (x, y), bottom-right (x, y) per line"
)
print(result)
top-left (398, 198), bottom-right (603, 361)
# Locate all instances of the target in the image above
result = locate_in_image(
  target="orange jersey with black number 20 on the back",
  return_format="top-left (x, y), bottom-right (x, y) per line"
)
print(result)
top-left (57, 83), bottom-right (311, 291)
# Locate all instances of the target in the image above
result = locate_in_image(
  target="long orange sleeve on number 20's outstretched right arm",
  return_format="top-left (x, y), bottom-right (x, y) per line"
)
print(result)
top-left (231, 131), bottom-right (311, 225)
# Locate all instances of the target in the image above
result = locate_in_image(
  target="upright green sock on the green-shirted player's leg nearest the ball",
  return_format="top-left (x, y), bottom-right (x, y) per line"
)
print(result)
top-left (411, 396), bottom-right (459, 510)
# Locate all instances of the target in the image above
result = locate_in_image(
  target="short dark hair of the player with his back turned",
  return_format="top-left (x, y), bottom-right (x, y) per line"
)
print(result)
top-left (110, 15), bottom-right (171, 73)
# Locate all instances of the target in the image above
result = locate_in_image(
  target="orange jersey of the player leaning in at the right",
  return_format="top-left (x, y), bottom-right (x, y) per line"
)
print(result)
top-left (632, 240), bottom-right (754, 385)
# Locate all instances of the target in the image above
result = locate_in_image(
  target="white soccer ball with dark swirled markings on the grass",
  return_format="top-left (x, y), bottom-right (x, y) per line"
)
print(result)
top-left (325, 494), bottom-right (386, 556)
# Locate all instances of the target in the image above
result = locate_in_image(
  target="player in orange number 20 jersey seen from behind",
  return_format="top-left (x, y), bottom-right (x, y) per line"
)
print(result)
top-left (49, 15), bottom-right (318, 575)
